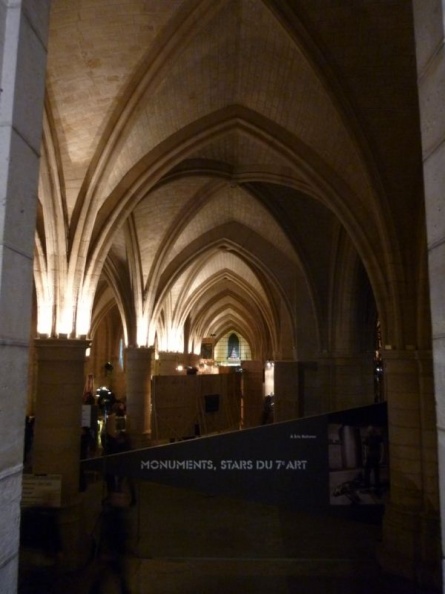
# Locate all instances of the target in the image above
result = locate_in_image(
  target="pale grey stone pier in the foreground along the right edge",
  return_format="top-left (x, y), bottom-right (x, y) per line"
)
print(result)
top-left (413, 0), bottom-right (445, 584)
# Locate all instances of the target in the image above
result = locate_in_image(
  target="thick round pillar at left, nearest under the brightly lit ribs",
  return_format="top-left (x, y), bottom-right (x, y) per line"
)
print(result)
top-left (32, 339), bottom-right (90, 568)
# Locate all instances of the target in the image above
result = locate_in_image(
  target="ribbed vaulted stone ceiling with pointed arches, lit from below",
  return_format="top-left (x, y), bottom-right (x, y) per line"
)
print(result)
top-left (40, 0), bottom-right (422, 357)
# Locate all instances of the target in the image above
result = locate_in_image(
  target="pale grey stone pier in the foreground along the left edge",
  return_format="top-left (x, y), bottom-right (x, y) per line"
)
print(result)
top-left (0, 0), bottom-right (49, 594)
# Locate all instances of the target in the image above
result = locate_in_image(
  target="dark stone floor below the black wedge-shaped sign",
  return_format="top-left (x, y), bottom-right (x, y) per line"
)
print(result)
top-left (19, 481), bottom-right (440, 594)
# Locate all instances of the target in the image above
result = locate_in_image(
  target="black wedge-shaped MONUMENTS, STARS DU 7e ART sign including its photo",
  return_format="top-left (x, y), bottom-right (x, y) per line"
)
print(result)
top-left (82, 404), bottom-right (388, 510)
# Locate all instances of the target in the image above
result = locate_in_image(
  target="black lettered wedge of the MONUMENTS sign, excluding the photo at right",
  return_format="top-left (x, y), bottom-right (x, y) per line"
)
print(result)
top-left (83, 417), bottom-right (328, 508)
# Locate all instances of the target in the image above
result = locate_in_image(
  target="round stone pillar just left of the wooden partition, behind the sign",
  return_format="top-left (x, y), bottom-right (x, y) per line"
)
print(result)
top-left (125, 347), bottom-right (154, 448)
